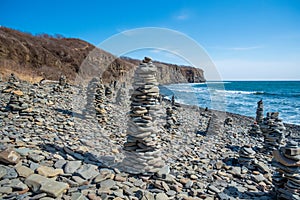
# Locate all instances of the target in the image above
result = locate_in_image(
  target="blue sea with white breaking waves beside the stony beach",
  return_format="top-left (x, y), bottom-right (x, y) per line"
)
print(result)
top-left (160, 81), bottom-right (300, 125)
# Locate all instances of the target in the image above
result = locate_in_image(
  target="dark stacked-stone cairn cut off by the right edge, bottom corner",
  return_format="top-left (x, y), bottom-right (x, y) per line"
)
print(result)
top-left (272, 140), bottom-right (300, 200)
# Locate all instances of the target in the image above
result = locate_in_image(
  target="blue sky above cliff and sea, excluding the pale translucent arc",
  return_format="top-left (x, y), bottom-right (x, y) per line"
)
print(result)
top-left (0, 0), bottom-right (300, 80)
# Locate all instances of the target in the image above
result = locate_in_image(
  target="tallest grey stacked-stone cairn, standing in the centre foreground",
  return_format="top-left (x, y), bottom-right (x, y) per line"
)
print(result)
top-left (120, 57), bottom-right (164, 175)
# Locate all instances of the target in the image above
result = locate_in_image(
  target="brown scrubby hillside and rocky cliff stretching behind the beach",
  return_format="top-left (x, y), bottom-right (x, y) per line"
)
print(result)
top-left (0, 27), bottom-right (205, 84)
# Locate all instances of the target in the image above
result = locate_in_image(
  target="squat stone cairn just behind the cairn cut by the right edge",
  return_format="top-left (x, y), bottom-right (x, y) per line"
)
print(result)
top-left (260, 112), bottom-right (286, 153)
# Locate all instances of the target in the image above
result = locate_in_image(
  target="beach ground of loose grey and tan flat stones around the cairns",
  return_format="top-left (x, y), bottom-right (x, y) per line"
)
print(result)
top-left (0, 72), bottom-right (300, 200)
